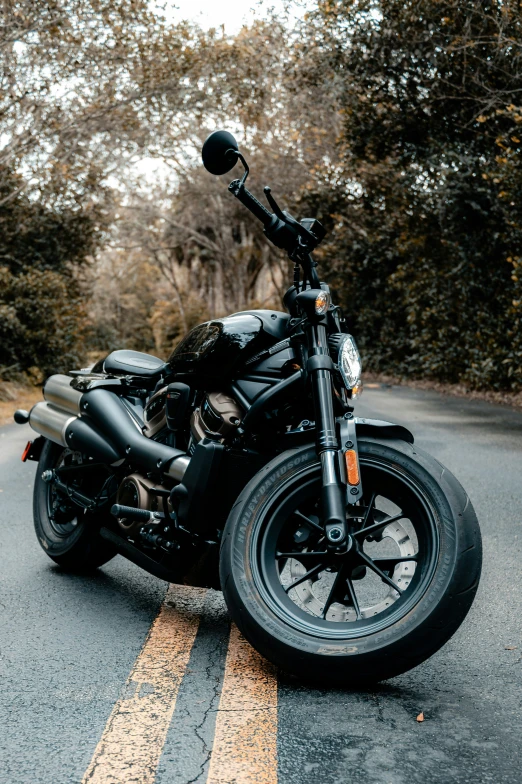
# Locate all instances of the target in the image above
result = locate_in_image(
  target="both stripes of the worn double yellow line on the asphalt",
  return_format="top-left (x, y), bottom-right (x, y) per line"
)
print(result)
top-left (82, 585), bottom-right (277, 784)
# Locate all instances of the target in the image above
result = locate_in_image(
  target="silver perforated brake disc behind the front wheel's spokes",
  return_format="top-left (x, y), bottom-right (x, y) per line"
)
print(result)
top-left (281, 523), bottom-right (416, 622)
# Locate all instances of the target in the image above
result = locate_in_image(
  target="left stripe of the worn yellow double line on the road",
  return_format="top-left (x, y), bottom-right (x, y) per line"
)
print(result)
top-left (82, 585), bottom-right (206, 784)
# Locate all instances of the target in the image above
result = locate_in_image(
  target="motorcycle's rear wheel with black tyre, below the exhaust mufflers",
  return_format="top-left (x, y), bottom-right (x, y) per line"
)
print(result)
top-left (33, 441), bottom-right (116, 571)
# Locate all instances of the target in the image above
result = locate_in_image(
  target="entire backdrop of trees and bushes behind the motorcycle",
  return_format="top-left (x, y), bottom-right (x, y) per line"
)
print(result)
top-left (0, 0), bottom-right (522, 389)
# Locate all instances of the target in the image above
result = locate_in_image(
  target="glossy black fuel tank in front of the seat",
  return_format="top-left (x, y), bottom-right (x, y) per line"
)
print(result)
top-left (168, 310), bottom-right (290, 380)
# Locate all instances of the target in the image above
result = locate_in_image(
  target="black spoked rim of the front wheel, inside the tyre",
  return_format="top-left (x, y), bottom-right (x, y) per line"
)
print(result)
top-left (250, 458), bottom-right (440, 640)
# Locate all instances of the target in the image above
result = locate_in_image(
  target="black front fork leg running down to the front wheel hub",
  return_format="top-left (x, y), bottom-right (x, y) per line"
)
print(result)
top-left (308, 325), bottom-right (347, 546)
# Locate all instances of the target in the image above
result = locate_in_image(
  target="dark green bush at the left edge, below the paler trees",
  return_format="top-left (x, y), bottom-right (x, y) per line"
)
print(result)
top-left (0, 167), bottom-right (106, 379)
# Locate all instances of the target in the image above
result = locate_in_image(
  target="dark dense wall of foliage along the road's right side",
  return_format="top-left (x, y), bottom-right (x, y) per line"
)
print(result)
top-left (301, 0), bottom-right (522, 389)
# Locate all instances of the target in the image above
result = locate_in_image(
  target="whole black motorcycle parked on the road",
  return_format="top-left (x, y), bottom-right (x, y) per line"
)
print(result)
top-left (15, 131), bottom-right (481, 684)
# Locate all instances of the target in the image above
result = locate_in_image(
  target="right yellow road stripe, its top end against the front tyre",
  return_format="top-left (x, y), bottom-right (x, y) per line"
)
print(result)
top-left (207, 625), bottom-right (277, 784)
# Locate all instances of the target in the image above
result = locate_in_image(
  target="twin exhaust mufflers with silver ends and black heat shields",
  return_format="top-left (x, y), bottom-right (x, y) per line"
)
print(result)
top-left (29, 374), bottom-right (190, 482)
